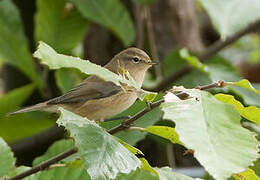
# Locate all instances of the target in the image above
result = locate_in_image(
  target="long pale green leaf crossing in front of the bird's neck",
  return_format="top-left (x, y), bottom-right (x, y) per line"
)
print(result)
top-left (34, 42), bottom-right (140, 88)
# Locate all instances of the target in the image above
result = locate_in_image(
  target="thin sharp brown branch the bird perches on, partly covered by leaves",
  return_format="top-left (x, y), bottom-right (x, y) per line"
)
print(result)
top-left (7, 81), bottom-right (225, 180)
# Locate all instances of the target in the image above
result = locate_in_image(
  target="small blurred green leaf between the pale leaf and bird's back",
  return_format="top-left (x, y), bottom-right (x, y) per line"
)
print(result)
top-left (55, 68), bottom-right (83, 94)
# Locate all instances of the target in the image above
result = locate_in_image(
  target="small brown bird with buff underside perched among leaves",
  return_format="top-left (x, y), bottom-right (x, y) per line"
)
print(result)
top-left (10, 48), bottom-right (155, 122)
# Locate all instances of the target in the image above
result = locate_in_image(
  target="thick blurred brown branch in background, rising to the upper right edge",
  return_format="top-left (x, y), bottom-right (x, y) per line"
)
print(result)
top-left (147, 20), bottom-right (260, 92)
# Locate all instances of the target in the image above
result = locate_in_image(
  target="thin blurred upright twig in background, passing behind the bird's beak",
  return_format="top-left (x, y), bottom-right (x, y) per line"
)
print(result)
top-left (144, 6), bottom-right (163, 80)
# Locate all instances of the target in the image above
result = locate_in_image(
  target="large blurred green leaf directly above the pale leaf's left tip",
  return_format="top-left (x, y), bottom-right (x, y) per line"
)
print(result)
top-left (35, 0), bottom-right (88, 54)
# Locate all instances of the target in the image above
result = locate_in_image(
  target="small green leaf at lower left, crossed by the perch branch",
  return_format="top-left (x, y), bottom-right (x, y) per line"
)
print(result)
top-left (33, 139), bottom-right (78, 166)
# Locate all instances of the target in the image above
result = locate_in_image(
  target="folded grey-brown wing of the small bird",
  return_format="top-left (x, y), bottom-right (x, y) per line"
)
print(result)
top-left (47, 76), bottom-right (121, 105)
